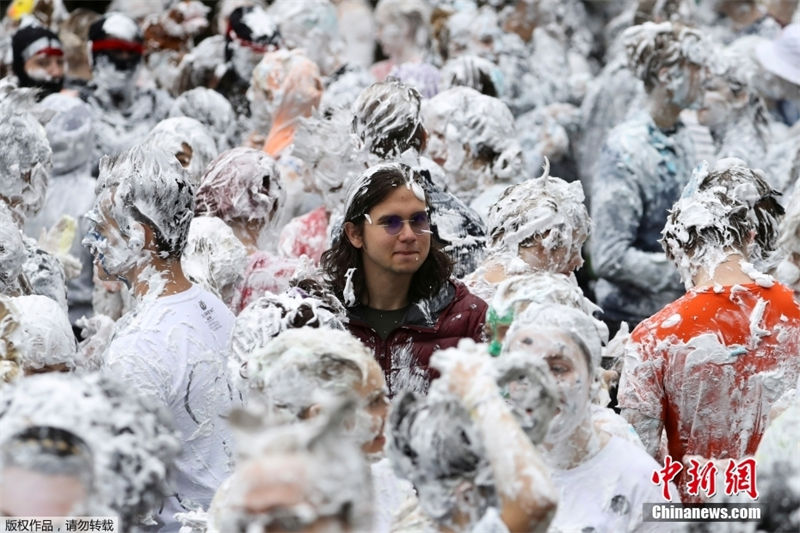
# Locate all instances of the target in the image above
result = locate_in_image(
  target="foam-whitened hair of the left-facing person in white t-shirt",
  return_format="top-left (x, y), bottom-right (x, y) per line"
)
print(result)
top-left (98, 141), bottom-right (194, 258)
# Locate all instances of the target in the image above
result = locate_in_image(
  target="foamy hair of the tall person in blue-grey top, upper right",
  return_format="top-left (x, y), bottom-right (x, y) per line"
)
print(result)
top-left (622, 22), bottom-right (703, 91)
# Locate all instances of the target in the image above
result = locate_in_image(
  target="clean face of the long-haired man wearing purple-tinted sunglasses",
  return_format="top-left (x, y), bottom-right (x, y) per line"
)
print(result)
top-left (348, 186), bottom-right (431, 278)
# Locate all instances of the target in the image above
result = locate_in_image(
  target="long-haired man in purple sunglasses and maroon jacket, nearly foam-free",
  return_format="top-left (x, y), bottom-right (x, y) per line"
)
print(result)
top-left (322, 163), bottom-right (487, 394)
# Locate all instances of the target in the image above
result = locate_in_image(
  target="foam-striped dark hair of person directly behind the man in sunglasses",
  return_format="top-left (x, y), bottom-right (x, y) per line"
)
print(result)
top-left (352, 78), bottom-right (425, 159)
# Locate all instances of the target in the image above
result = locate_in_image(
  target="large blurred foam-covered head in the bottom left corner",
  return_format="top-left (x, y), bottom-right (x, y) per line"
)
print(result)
top-left (0, 373), bottom-right (180, 531)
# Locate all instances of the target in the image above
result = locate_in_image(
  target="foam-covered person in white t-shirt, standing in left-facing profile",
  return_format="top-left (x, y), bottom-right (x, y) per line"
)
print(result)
top-left (84, 141), bottom-right (234, 531)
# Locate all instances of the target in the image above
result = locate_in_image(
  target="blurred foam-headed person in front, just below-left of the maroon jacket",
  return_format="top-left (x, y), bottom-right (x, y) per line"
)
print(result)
top-left (236, 327), bottom-right (413, 533)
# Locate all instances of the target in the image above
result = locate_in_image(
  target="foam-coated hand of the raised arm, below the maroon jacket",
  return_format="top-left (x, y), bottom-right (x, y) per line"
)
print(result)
top-left (430, 339), bottom-right (500, 410)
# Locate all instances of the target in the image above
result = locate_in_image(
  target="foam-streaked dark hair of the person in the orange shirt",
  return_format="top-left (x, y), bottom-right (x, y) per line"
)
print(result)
top-left (661, 158), bottom-right (784, 262)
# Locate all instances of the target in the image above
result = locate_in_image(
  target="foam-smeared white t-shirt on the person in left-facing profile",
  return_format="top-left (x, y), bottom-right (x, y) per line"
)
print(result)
top-left (106, 285), bottom-right (234, 531)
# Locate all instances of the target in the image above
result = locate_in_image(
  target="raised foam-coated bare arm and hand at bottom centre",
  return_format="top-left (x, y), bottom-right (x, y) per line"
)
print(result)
top-left (431, 340), bottom-right (557, 532)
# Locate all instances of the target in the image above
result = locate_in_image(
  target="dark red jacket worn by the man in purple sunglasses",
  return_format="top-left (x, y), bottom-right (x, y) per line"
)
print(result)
top-left (348, 280), bottom-right (488, 395)
